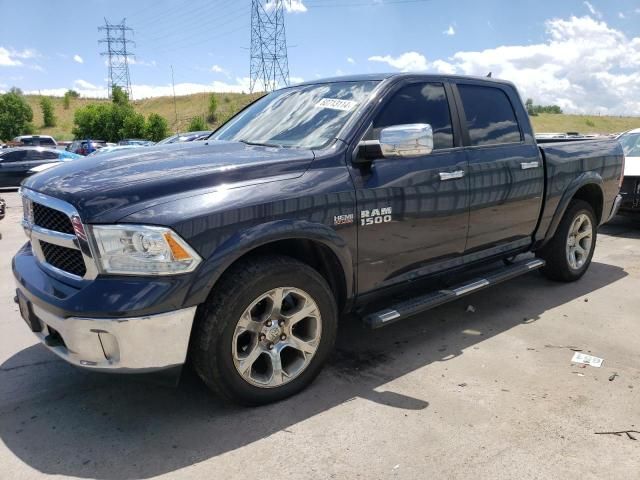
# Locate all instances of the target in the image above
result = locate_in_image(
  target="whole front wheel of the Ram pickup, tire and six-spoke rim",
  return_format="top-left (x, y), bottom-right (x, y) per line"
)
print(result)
top-left (192, 256), bottom-right (337, 405)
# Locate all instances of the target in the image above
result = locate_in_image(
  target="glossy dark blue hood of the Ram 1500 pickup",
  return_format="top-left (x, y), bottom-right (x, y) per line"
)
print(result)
top-left (22, 141), bottom-right (314, 223)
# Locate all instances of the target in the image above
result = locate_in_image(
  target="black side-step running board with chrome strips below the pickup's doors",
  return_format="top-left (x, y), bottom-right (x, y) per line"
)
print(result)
top-left (363, 258), bottom-right (545, 328)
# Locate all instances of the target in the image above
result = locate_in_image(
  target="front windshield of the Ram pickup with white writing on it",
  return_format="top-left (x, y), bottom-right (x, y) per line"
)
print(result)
top-left (211, 81), bottom-right (378, 149)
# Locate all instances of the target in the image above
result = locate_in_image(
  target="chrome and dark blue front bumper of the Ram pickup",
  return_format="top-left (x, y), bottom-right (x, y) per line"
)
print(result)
top-left (12, 243), bottom-right (197, 373)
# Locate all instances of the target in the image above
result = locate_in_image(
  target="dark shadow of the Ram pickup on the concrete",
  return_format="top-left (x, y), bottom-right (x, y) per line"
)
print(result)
top-left (0, 263), bottom-right (627, 480)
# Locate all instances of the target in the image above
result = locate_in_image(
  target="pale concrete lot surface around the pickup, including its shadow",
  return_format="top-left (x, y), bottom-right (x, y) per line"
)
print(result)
top-left (0, 189), bottom-right (640, 480)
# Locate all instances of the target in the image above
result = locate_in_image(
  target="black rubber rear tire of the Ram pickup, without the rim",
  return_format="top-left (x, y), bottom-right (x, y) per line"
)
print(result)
top-left (536, 200), bottom-right (598, 282)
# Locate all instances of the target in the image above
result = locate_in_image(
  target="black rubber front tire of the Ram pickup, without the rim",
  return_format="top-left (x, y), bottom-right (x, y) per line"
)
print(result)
top-left (190, 255), bottom-right (338, 405)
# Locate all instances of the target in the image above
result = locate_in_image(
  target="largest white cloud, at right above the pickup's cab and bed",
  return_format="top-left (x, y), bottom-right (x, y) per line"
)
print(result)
top-left (370, 16), bottom-right (640, 115)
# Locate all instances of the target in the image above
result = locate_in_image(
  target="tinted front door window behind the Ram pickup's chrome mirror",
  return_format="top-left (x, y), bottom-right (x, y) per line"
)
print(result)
top-left (373, 83), bottom-right (453, 149)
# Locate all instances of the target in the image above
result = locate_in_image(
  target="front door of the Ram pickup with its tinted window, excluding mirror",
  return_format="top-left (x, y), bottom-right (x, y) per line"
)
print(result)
top-left (354, 81), bottom-right (469, 293)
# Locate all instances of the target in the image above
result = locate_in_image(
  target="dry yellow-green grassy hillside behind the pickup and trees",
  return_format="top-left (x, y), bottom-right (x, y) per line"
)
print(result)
top-left (26, 93), bottom-right (640, 140)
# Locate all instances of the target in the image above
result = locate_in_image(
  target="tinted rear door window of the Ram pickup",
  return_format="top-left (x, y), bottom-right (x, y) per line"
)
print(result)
top-left (458, 85), bottom-right (521, 145)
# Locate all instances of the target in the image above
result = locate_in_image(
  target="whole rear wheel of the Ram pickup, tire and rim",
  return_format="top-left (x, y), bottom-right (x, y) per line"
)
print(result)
top-left (537, 200), bottom-right (597, 282)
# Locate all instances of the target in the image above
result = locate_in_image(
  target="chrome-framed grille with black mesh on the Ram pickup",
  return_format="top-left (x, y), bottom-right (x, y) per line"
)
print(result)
top-left (21, 188), bottom-right (97, 281)
